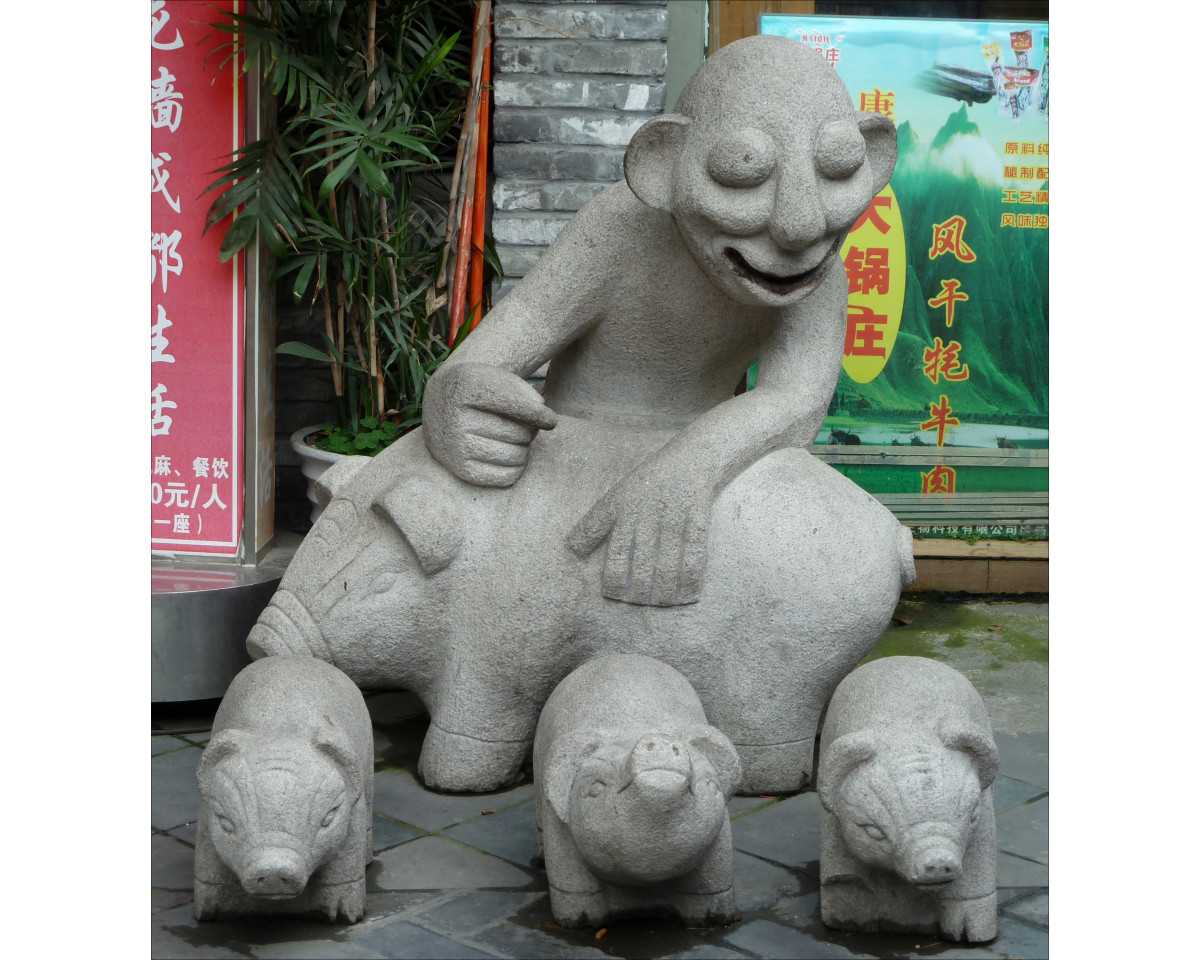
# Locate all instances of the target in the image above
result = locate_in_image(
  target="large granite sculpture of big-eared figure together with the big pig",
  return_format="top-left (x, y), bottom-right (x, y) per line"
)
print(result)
top-left (248, 31), bottom-right (914, 793)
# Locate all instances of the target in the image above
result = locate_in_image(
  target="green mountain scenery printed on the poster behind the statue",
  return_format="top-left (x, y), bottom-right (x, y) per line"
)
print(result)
top-left (829, 104), bottom-right (1049, 427)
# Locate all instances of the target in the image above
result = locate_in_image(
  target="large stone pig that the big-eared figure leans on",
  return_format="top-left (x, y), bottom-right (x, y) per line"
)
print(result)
top-left (247, 416), bottom-right (913, 793)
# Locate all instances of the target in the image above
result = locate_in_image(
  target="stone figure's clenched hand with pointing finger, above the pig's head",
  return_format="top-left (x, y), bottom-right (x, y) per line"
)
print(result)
top-left (424, 364), bottom-right (558, 487)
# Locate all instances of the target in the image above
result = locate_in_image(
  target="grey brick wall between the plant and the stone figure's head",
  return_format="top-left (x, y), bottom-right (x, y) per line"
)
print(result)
top-left (492, 0), bottom-right (667, 300)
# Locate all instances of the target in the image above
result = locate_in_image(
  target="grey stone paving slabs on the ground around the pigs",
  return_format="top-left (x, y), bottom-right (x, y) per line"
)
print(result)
top-left (150, 599), bottom-right (1050, 960)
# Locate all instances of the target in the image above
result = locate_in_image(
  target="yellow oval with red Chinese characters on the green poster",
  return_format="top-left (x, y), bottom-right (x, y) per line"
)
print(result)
top-left (841, 184), bottom-right (908, 383)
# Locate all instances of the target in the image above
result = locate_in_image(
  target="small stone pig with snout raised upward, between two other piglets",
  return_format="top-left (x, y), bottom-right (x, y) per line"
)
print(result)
top-left (534, 654), bottom-right (740, 926)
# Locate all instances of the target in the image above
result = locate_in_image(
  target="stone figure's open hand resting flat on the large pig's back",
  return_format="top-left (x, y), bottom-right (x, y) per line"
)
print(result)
top-left (566, 456), bottom-right (716, 607)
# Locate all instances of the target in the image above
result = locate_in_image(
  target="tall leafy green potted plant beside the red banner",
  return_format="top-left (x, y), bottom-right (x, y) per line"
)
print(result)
top-left (208, 0), bottom-right (498, 518)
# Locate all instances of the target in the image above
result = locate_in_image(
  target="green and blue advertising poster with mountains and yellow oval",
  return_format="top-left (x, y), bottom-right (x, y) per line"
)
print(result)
top-left (761, 14), bottom-right (1050, 539)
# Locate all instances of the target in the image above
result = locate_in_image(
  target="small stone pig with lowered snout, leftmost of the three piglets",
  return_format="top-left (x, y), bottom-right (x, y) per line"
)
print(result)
top-left (194, 656), bottom-right (374, 923)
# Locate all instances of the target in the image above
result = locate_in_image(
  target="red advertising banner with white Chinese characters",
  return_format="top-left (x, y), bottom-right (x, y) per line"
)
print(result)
top-left (150, 0), bottom-right (246, 557)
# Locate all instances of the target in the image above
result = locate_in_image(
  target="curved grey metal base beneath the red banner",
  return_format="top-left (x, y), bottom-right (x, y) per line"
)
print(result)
top-left (150, 530), bottom-right (302, 703)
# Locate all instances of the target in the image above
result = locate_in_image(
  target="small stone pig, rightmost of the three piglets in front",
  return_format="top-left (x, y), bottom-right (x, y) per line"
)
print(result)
top-left (817, 656), bottom-right (997, 942)
